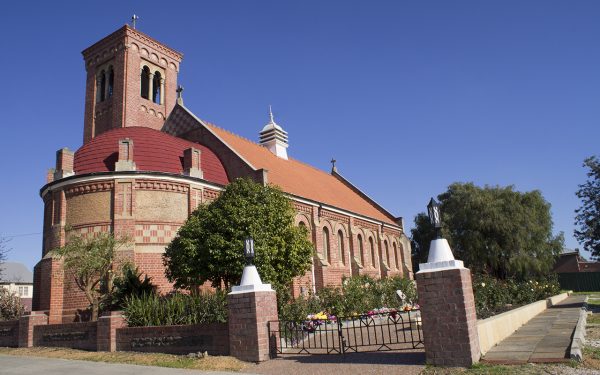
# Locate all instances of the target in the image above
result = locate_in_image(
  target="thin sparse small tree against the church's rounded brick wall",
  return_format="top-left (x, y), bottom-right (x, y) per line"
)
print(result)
top-left (53, 233), bottom-right (129, 321)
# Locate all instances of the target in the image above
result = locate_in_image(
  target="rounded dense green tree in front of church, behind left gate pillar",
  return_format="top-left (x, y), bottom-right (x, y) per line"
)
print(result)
top-left (164, 179), bottom-right (313, 290)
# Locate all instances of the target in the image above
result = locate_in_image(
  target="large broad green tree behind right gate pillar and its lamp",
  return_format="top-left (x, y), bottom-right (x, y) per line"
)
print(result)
top-left (411, 183), bottom-right (564, 279)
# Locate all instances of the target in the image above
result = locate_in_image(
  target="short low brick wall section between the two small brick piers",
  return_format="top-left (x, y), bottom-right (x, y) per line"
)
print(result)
top-left (33, 322), bottom-right (98, 350)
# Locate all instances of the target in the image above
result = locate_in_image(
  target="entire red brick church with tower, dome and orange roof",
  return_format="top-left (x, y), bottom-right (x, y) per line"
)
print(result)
top-left (33, 26), bottom-right (412, 323)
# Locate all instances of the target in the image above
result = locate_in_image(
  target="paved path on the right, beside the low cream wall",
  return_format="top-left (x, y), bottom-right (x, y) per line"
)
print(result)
top-left (483, 295), bottom-right (586, 364)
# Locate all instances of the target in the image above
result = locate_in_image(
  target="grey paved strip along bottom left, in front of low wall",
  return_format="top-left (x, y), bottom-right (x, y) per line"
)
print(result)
top-left (0, 355), bottom-right (251, 375)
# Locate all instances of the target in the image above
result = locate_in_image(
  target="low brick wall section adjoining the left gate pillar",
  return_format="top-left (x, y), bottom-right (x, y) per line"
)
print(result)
top-left (116, 323), bottom-right (229, 355)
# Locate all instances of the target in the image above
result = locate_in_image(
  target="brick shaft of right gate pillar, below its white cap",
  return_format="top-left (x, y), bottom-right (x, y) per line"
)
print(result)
top-left (416, 268), bottom-right (480, 367)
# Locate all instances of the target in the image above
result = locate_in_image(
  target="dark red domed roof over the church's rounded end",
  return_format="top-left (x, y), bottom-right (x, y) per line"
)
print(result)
top-left (75, 127), bottom-right (228, 185)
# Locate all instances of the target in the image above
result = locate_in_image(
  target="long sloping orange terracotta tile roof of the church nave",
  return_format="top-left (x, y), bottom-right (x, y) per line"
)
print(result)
top-left (203, 121), bottom-right (396, 225)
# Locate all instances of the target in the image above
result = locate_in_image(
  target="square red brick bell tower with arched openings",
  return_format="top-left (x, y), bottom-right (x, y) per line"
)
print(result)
top-left (82, 25), bottom-right (183, 144)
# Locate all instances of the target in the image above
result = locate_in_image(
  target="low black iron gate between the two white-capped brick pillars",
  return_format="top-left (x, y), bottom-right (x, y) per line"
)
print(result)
top-left (269, 310), bottom-right (424, 354)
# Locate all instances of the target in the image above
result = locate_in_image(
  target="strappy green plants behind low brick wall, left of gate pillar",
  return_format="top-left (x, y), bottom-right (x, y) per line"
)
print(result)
top-left (123, 290), bottom-right (227, 327)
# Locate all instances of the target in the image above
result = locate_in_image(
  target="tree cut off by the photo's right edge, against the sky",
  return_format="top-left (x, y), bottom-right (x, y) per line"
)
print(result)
top-left (575, 156), bottom-right (600, 259)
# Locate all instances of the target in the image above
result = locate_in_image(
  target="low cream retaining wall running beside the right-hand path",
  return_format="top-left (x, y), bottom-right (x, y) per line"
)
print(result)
top-left (477, 292), bottom-right (571, 355)
